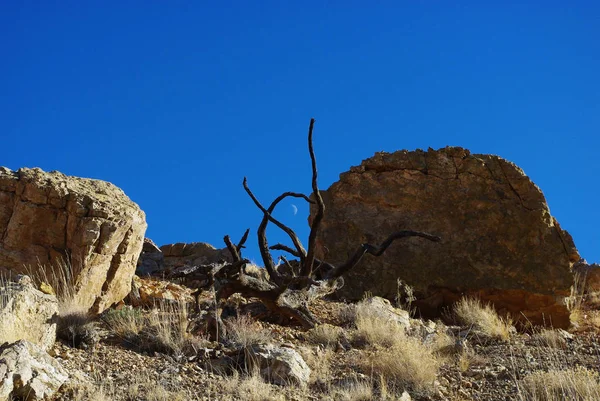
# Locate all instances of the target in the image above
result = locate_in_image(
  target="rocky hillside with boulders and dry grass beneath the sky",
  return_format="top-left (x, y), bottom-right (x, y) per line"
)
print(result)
top-left (0, 152), bottom-right (600, 401)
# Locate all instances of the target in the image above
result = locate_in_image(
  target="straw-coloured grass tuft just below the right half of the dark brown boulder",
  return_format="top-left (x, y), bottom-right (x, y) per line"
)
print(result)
top-left (454, 298), bottom-right (514, 341)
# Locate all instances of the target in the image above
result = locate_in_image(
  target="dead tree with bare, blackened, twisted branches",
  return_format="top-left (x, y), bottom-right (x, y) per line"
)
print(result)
top-left (213, 119), bottom-right (440, 329)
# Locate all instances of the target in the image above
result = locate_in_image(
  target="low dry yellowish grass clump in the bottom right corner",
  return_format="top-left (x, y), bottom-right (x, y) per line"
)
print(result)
top-left (519, 367), bottom-right (600, 401)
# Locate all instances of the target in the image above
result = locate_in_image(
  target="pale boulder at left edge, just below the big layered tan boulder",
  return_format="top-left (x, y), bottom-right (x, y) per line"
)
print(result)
top-left (0, 276), bottom-right (58, 350)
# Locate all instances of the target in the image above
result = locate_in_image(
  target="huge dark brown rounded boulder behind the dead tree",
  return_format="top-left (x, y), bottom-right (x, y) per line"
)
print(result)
top-left (312, 147), bottom-right (579, 327)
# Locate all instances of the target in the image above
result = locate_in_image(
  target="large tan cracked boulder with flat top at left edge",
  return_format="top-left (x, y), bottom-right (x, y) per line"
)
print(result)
top-left (0, 168), bottom-right (146, 313)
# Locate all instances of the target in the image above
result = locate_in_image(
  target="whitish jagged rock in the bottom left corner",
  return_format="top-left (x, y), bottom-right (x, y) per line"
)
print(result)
top-left (0, 340), bottom-right (69, 401)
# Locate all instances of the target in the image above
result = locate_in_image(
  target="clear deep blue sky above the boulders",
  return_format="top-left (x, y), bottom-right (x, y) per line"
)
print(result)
top-left (0, 0), bottom-right (600, 262)
